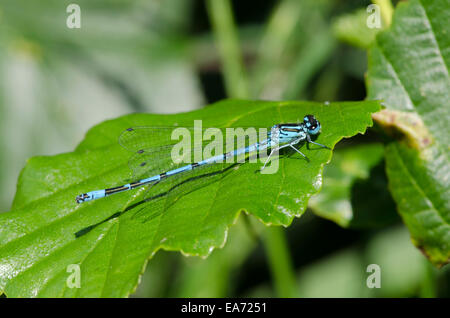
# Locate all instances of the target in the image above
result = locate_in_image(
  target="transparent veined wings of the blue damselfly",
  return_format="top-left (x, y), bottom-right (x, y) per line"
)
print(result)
top-left (119, 127), bottom-right (268, 222)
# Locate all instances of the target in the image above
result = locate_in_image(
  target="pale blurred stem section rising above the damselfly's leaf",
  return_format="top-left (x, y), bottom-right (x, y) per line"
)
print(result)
top-left (206, 0), bottom-right (249, 98)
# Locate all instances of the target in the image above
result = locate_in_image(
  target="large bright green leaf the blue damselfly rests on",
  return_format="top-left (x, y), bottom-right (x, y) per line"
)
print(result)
top-left (0, 100), bottom-right (380, 297)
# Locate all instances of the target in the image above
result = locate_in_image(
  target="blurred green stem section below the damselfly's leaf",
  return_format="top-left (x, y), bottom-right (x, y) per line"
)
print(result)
top-left (264, 226), bottom-right (297, 298)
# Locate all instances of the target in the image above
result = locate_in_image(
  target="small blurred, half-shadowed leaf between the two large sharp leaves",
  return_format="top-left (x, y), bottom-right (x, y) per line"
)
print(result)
top-left (309, 143), bottom-right (398, 228)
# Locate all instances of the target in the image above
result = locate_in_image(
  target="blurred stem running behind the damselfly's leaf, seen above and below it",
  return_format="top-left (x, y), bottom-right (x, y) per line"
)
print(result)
top-left (206, 0), bottom-right (295, 297)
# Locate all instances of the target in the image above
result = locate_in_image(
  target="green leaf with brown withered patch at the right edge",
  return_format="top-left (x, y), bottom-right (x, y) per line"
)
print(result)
top-left (367, 0), bottom-right (450, 266)
